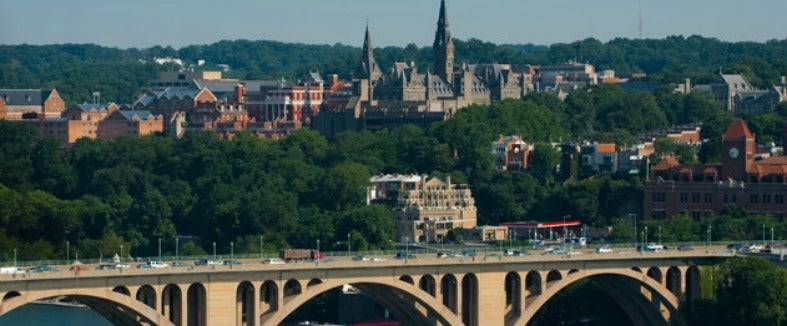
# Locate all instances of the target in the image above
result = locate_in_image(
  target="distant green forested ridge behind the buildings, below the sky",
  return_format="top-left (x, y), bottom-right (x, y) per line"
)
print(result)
top-left (0, 35), bottom-right (787, 103)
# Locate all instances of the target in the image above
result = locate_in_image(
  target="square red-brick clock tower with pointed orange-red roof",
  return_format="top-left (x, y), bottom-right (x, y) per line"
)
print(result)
top-left (721, 120), bottom-right (757, 181)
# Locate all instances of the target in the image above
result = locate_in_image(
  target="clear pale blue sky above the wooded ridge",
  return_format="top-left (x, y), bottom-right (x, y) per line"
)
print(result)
top-left (0, 0), bottom-right (787, 48)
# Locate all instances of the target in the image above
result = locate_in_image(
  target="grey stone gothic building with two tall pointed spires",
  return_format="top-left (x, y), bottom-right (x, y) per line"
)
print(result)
top-left (312, 0), bottom-right (532, 137)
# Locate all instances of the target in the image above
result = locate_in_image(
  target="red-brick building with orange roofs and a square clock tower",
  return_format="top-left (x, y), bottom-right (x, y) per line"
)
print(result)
top-left (643, 120), bottom-right (787, 221)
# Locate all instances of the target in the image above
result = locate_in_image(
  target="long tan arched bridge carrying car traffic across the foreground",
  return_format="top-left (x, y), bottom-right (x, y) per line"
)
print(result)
top-left (0, 251), bottom-right (730, 326)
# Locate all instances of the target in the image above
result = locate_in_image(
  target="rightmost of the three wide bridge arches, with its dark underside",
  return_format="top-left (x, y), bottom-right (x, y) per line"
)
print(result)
top-left (514, 268), bottom-right (684, 325)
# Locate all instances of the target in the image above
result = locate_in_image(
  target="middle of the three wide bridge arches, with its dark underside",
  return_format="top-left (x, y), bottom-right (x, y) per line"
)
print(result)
top-left (260, 277), bottom-right (462, 325)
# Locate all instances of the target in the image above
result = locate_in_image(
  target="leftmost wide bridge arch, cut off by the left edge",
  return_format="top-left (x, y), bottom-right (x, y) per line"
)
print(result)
top-left (0, 289), bottom-right (174, 326)
